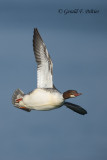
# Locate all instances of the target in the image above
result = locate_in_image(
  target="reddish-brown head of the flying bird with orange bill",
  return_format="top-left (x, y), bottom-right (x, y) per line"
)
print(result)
top-left (63, 90), bottom-right (82, 99)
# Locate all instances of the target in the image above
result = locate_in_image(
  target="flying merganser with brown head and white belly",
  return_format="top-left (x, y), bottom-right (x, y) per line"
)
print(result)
top-left (12, 28), bottom-right (87, 115)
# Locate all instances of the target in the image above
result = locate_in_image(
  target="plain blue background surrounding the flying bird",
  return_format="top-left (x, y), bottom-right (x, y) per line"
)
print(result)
top-left (0, 0), bottom-right (107, 160)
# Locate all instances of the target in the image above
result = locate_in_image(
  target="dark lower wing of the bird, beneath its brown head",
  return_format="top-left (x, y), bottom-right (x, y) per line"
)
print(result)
top-left (64, 102), bottom-right (87, 115)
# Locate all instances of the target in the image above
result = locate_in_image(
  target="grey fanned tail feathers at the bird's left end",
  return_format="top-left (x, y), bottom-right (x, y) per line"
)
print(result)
top-left (12, 89), bottom-right (24, 108)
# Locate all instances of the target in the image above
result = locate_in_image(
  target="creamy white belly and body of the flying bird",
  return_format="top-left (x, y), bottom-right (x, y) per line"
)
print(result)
top-left (19, 89), bottom-right (64, 110)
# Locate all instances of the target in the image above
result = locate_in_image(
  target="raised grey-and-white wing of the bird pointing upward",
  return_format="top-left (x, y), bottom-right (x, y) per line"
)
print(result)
top-left (33, 28), bottom-right (53, 88)
